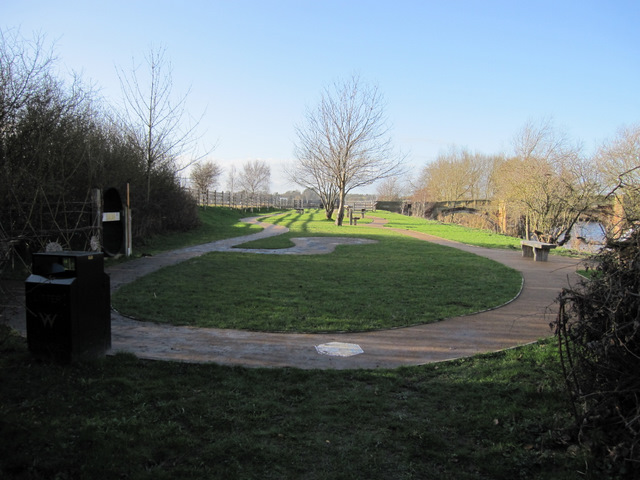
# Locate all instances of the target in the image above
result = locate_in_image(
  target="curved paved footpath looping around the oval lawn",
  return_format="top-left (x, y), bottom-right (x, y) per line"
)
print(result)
top-left (5, 218), bottom-right (579, 369)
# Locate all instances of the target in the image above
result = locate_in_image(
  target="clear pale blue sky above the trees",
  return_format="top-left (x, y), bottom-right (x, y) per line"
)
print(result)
top-left (0, 0), bottom-right (640, 192)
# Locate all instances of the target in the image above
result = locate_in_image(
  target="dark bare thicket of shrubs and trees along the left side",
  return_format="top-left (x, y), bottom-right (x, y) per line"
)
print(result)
top-left (0, 28), bottom-right (198, 255)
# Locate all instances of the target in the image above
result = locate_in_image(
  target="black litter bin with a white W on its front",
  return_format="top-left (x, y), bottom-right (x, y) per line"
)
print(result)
top-left (25, 252), bottom-right (111, 362)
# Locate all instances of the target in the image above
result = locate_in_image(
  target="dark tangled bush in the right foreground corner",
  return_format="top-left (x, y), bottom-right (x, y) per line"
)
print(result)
top-left (556, 232), bottom-right (640, 479)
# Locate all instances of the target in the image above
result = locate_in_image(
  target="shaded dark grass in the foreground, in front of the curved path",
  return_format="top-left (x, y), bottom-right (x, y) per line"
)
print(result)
top-left (0, 329), bottom-right (588, 480)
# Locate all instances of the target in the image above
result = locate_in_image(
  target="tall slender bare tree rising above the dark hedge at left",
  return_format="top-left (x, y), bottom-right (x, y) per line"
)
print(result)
top-left (118, 48), bottom-right (203, 201)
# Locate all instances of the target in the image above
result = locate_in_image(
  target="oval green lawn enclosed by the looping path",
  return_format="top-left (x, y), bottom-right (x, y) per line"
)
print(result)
top-left (112, 212), bottom-right (522, 332)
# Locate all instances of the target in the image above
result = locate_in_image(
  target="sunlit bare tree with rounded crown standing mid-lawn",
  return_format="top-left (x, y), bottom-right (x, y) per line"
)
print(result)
top-left (289, 77), bottom-right (403, 225)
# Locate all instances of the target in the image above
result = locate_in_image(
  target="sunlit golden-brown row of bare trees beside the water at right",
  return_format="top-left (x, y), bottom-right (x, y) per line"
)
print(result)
top-left (396, 118), bottom-right (640, 245)
